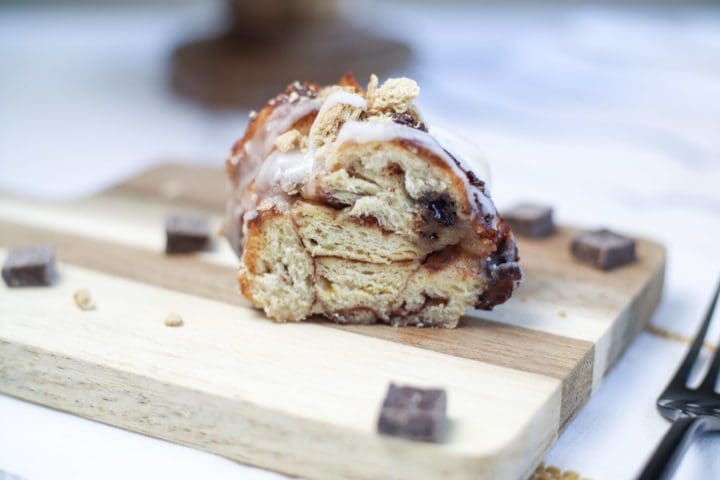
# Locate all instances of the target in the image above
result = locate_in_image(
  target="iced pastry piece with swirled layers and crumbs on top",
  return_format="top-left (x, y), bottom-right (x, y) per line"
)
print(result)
top-left (226, 75), bottom-right (522, 328)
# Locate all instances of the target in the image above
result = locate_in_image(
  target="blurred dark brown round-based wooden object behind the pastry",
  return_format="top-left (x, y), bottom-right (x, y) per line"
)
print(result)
top-left (172, 0), bottom-right (410, 107)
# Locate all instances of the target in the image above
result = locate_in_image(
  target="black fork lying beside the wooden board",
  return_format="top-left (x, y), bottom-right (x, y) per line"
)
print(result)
top-left (638, 284), bottom-right (720, 480)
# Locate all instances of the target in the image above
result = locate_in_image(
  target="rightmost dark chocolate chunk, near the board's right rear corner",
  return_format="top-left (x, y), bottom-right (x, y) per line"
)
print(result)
top-left (570, 229), bottom-right (635, 270)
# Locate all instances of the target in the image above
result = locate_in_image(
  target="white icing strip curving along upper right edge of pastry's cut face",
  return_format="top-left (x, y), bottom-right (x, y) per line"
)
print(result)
top-left (337, 121), bottom-right (497, 228)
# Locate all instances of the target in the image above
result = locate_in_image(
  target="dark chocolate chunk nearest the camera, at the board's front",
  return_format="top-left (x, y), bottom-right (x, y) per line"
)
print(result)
top-left (378, 383), bottom-right (447, 442)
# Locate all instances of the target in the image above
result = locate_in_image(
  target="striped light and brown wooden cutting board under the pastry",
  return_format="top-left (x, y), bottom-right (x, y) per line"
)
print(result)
top-left (0, 165), bottom-right (665, 480)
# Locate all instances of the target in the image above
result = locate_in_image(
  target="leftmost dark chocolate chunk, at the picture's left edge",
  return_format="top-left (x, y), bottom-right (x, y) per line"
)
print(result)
top-left (2, 245), bottom-right (56, 287)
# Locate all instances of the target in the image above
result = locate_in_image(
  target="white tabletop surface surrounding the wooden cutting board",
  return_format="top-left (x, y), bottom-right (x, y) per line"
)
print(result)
top-left (0, 3), bottom-right (720, 480)
